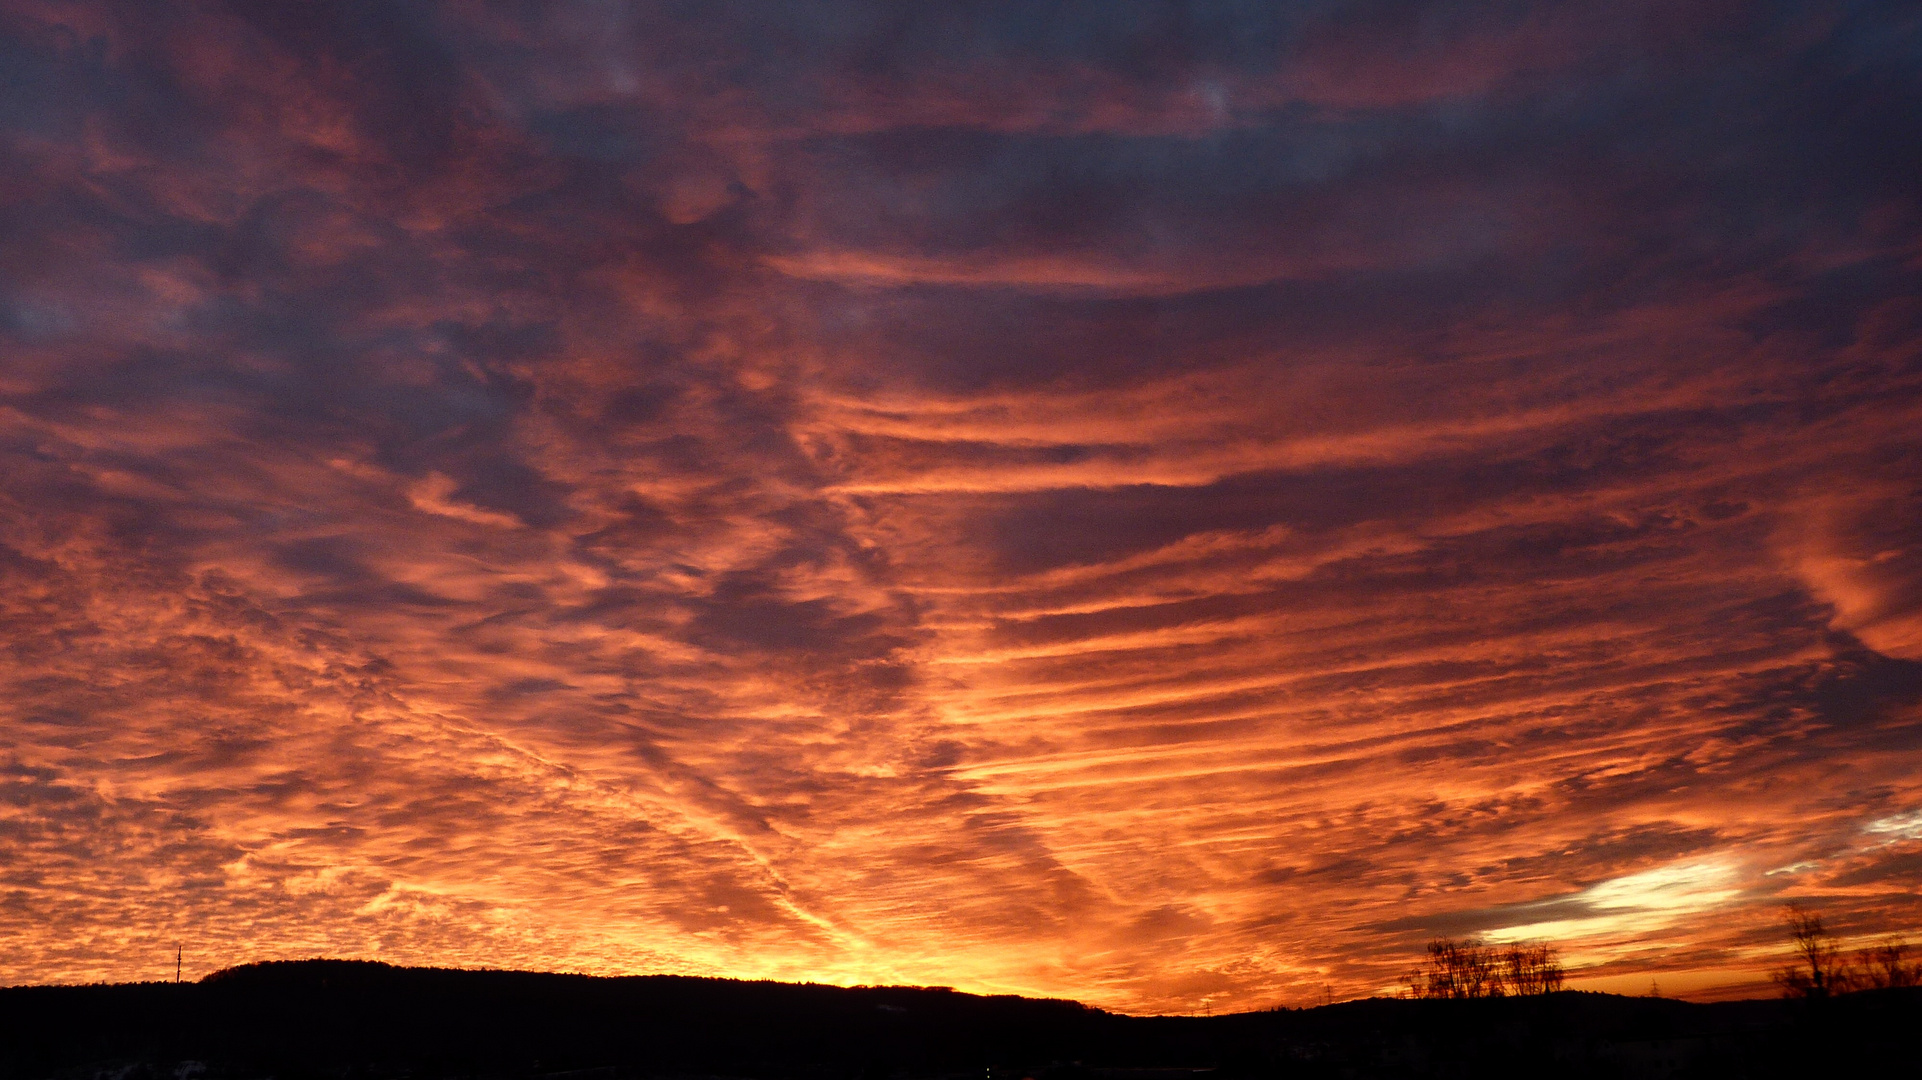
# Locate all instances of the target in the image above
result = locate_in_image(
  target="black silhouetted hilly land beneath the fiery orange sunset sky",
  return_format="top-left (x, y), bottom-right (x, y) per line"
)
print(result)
top-left (0, 961), bottom-right (1922, 1080)
